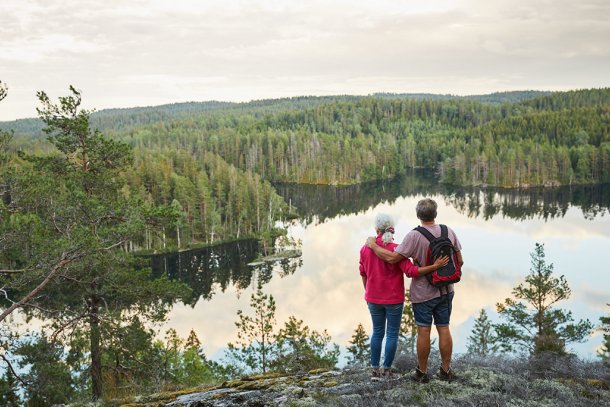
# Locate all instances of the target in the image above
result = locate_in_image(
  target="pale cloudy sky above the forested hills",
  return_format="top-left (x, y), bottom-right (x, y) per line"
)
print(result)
top-left (0, 0), bottom-right (610, 120)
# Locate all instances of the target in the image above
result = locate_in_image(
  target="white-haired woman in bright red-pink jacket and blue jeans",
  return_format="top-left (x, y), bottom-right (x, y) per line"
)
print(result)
top-left (360, 214), bottom-right (449, 380)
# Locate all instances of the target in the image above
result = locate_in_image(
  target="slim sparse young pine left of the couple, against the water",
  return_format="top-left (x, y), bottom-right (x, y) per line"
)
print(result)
top-left (227, 284), bottom-right (275, 373)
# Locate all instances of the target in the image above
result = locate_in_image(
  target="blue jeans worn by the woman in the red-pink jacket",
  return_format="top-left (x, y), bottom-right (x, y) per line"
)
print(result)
top-left (368, 302), bottom-right (404, 369)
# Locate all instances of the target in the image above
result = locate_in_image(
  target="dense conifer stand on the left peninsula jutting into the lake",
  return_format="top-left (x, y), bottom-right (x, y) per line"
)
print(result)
top-left (125, 146), bottom-right (288, 250)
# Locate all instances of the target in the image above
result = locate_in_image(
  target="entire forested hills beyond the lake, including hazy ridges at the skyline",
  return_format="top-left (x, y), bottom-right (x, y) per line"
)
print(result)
top-left (3, 88), bottom-right (610, 190)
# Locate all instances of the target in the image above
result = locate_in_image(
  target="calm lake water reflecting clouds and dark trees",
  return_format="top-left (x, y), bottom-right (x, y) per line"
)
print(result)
top-left (153, 176), bottom-right (610, 360)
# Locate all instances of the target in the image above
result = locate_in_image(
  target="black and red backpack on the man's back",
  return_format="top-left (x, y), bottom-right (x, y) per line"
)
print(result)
top-left (413, 225), bottom-right (462, 287)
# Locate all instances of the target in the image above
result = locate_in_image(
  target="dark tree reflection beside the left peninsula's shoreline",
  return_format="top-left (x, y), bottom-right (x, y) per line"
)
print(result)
top-left (150, 239), bottom-right (302, 306)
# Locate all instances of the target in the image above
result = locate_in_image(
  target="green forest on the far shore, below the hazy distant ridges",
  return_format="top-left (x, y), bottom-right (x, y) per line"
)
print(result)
top-left (115, 89), bottom-right (610, 186)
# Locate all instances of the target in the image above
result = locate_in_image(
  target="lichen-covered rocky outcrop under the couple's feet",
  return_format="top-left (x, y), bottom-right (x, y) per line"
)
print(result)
top-left (120, 358), bottom-right (610, 407)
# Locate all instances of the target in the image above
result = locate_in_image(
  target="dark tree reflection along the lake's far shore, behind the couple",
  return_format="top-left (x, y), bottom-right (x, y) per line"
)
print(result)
top-left (276, 173), bottom-right (610, 224)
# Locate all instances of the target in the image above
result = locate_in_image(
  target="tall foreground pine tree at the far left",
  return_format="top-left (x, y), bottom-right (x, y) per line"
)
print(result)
top-left (0, 87), bottom-right (189, 399)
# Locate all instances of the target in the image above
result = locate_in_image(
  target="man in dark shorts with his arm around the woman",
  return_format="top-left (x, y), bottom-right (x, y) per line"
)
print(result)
top-left (367, 198), bottom-right (464, 383)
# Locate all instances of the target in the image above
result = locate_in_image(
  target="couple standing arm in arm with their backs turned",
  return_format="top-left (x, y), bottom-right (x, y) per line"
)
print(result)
top-left (360, 199), bottom-right (463, 383)
